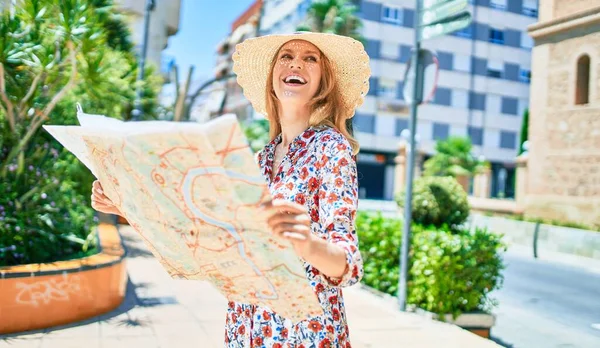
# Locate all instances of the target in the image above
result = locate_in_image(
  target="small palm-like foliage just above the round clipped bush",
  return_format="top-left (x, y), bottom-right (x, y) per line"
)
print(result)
top-left (423, 137), bottom-right (487, 177)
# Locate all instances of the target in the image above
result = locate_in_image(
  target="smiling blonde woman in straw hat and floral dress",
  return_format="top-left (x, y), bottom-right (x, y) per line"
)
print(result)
top-left (93, 33), bottom-right (370, 347)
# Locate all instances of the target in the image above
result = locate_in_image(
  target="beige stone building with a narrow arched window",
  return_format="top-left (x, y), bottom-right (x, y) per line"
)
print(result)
top-left (518, 0), bottom-right (600, 225)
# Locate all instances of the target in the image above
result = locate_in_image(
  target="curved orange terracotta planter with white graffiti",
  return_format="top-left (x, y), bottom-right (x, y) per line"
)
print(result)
top-left (0, 224), bottom-right (127, 334)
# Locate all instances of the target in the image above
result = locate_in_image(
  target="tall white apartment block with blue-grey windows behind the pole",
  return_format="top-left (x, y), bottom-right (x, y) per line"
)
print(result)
top-left (260, 0), bottom-right (538, 200)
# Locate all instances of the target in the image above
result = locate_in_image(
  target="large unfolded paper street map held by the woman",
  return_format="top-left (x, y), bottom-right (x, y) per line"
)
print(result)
top-left (44, 111), bottom-right (323, 321)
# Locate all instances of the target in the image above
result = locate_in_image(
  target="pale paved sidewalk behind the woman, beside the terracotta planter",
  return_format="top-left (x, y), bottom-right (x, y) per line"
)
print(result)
top-left (0, 226), bottom-right (499, 348)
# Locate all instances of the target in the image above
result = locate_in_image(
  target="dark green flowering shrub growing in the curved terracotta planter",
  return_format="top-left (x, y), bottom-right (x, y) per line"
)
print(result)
top-left (0, 136), bottom-right (97, 266)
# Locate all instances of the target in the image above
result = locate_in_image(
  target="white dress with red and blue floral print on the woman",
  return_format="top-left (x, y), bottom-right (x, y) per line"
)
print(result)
top-left (225, 126), bottom-right (363, 348)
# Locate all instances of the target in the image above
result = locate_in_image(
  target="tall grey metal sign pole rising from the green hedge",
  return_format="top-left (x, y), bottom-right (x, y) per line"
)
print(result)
top-left (398, 0), bottom-right (423, 311)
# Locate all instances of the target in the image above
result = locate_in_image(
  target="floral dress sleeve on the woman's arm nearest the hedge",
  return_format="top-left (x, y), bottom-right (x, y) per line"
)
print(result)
top-left (318, 142), bottom-right (363, 287)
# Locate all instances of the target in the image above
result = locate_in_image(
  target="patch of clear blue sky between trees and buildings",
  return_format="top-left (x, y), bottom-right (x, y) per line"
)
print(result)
top-left (163, 0), bottom-right (254, 83)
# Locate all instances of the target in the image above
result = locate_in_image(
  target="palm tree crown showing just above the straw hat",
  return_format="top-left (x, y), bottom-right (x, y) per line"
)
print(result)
top-left (296, 0), bottom-right (363, 134)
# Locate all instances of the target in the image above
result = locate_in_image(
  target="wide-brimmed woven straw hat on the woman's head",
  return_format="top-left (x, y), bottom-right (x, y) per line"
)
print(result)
top-left (232, 32), bottom-right (371, 118)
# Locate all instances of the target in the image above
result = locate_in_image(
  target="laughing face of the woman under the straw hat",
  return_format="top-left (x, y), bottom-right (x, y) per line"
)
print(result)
top-left (273, 40), bottom-right (321, 104)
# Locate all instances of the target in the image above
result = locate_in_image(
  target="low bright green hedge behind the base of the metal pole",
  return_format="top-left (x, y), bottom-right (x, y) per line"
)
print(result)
top-left (356, 212), bottom-right (505, 316)
